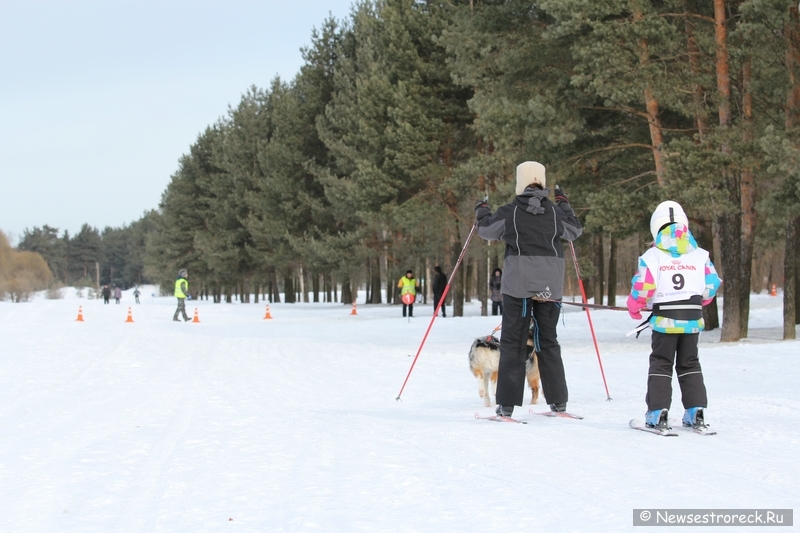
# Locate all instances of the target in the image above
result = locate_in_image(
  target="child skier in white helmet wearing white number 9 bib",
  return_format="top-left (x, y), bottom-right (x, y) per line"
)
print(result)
top-left (628, 201), bottom-right (722, 430)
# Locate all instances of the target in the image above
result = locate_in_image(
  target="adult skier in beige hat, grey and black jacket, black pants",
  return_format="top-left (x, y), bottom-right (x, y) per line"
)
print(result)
top-left (475, 161), bottom-right (583, 417)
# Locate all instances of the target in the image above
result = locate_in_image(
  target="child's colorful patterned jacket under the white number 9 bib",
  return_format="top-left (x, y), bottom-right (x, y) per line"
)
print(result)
top-left (627, 223), bottom-right (722, 334)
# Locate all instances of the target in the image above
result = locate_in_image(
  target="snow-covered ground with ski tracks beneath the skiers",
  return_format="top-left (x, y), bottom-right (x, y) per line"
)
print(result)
top-left (0, 289), bottom-right (800, 533)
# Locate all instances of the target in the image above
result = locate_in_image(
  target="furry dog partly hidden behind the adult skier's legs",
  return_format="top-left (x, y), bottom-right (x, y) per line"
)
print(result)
top-left (469, 331), bottom-right (539, 407)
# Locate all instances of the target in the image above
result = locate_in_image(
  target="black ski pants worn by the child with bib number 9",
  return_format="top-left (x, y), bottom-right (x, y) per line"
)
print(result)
top-left (645, 331), bottom-right (708, 411)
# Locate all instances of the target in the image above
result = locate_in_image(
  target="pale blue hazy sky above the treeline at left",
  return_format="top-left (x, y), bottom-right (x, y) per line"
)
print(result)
top-left (0, 0), bottom-right (353, 243)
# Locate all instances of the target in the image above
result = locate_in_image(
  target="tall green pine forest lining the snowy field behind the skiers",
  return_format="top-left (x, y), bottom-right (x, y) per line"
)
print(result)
top-left (6, 0), bottom-right (800, 341)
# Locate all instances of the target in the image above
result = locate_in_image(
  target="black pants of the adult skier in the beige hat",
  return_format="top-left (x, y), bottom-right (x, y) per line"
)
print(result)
top-left (497, 294), bottom-right (569, 406)
